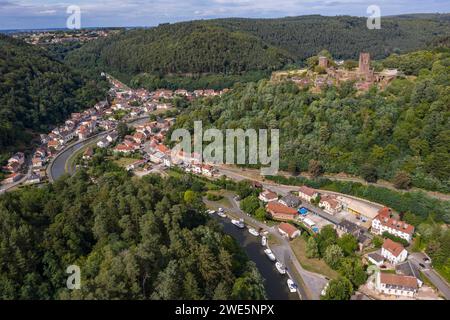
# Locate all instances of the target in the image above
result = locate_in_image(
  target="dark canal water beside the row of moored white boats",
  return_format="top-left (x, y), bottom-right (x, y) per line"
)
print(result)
top-left (213, 215), bottom-right (299, 300)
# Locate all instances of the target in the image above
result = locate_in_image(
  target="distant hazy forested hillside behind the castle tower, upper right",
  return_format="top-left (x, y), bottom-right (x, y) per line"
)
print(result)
top-left (212, 14), bottom-right (450, 60)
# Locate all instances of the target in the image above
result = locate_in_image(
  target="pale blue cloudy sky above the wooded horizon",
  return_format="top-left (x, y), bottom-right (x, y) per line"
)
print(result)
top-left (0, 0), bottom-right (450, 29)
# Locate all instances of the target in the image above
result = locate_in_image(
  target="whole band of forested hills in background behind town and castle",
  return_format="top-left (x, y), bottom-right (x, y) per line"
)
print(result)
top-left (64, 15), bottom-right (450, 89)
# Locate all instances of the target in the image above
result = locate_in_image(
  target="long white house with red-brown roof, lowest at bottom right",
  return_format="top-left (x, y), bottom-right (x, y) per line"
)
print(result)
top-left (376, 272), bottom-right (419, 298)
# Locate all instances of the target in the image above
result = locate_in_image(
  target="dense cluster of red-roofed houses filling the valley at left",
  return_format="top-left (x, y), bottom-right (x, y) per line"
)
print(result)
top-left (0, 74), bottom-right (227, 193)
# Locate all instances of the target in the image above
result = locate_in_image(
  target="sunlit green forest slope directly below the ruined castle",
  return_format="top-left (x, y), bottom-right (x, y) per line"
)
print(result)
top-left (170, 48), bottom-right (450, 192)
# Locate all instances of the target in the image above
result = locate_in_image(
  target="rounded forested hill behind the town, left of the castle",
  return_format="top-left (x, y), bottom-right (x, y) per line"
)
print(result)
top-left (67, 22), bottom-right (292, 84)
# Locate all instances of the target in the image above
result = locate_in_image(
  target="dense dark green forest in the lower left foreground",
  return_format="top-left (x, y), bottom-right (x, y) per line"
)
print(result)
top-left (0, 154), bottom-right (266, 299)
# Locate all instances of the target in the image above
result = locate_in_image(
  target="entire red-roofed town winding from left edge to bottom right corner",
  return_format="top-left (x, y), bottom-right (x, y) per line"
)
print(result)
top-left (2, 70), bottom-right (448, 300)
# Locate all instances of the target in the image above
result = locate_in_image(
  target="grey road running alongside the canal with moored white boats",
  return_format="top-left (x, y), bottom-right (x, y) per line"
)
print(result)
top-left (204, 195), bottom-right (328, 300)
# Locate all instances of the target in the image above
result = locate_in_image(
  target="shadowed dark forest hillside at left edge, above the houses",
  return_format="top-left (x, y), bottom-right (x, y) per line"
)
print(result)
top-left (0, 35), bottom-right (106, 159)
